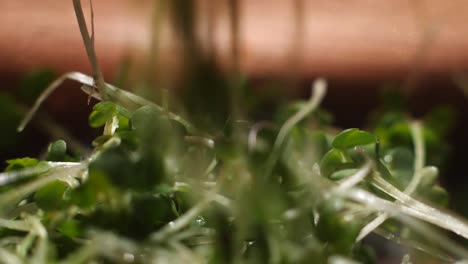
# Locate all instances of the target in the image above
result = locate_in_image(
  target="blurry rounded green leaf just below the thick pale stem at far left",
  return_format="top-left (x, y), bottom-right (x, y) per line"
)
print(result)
top-left (34, 181), bottom-right (69, 211)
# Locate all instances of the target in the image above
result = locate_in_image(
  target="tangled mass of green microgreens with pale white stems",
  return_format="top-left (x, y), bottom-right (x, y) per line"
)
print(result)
top-left (0, 0), bottom-right (468, 263)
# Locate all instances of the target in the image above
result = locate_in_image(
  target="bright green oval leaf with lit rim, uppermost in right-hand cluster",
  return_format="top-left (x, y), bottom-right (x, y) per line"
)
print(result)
top-left (332, 128), bottom-right (376, 149)
